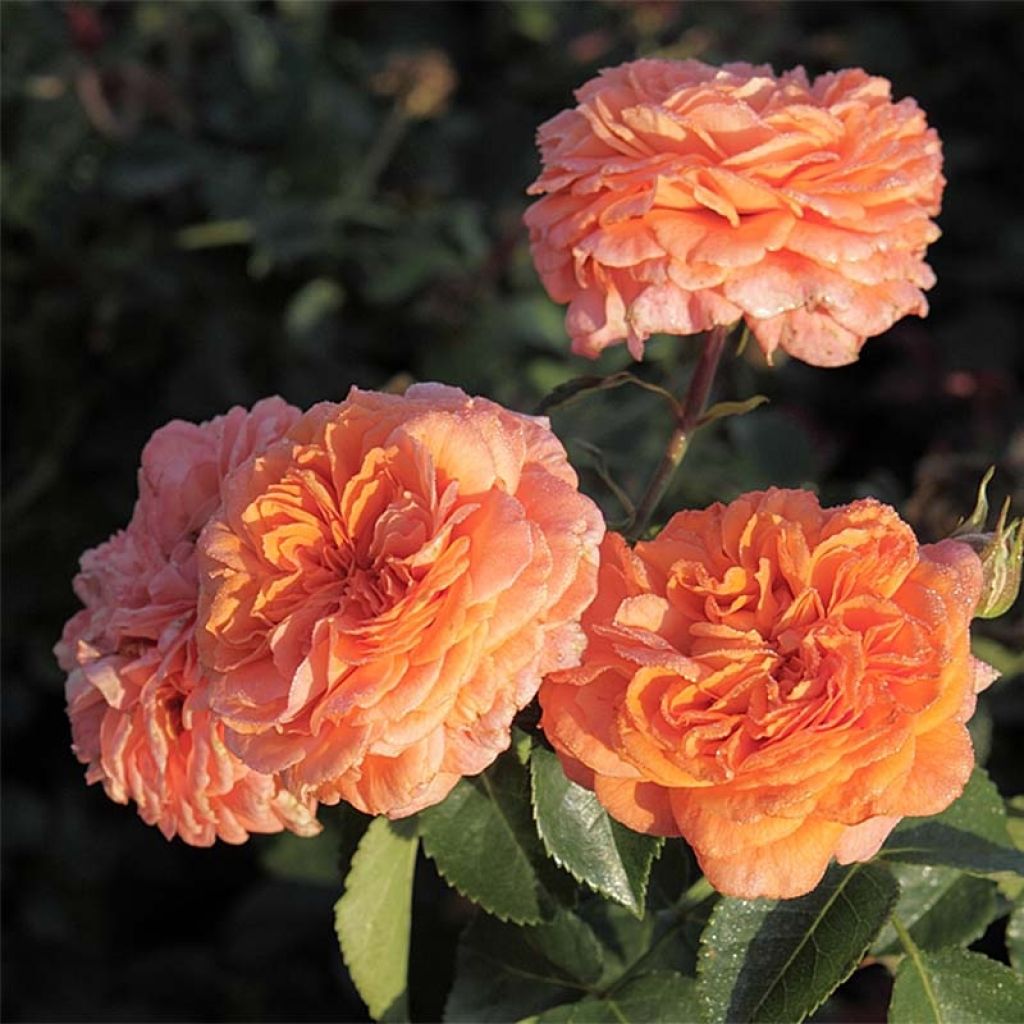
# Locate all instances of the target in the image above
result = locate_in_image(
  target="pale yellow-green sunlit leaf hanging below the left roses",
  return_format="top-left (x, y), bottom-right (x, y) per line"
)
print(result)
top-left (334, 818), bottom-right (417, 1020)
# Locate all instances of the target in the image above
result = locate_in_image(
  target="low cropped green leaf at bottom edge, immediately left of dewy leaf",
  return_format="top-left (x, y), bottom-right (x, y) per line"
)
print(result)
top-left (531, 971), bottom-right (700, 1024)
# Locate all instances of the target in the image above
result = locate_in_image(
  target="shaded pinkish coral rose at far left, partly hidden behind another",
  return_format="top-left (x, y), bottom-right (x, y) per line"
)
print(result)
top-left (55, 398), bottom-right (319, 846)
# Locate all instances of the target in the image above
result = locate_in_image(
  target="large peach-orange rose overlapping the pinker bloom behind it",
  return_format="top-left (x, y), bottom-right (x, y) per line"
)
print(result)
top-left (200, 384), bottom-right (604, 817)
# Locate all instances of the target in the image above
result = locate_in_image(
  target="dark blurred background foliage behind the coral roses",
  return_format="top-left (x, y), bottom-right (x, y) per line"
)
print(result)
top-left (6, 0), bottom-right (1024, 1021)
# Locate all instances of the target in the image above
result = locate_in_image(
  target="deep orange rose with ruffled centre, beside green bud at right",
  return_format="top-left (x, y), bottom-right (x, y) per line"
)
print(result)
top-left (541, 490), bottom-right (992, 898)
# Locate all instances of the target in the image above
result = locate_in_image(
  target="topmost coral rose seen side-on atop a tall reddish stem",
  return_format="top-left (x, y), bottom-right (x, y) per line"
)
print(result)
top-left (525, 60), bottom-right (945, 367)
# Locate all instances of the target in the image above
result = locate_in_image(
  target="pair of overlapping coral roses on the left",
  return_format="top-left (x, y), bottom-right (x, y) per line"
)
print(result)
top-left (57, 385), bottom-right (604, 831)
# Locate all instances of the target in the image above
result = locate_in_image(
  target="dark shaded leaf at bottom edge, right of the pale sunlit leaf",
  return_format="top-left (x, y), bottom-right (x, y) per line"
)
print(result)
top-left (444, 910), bottom-right (601, 1022)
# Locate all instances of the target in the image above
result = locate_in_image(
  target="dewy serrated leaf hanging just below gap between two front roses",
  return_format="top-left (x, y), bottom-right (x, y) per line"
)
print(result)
top-left (530, 746), bottom-right (660, 916)
